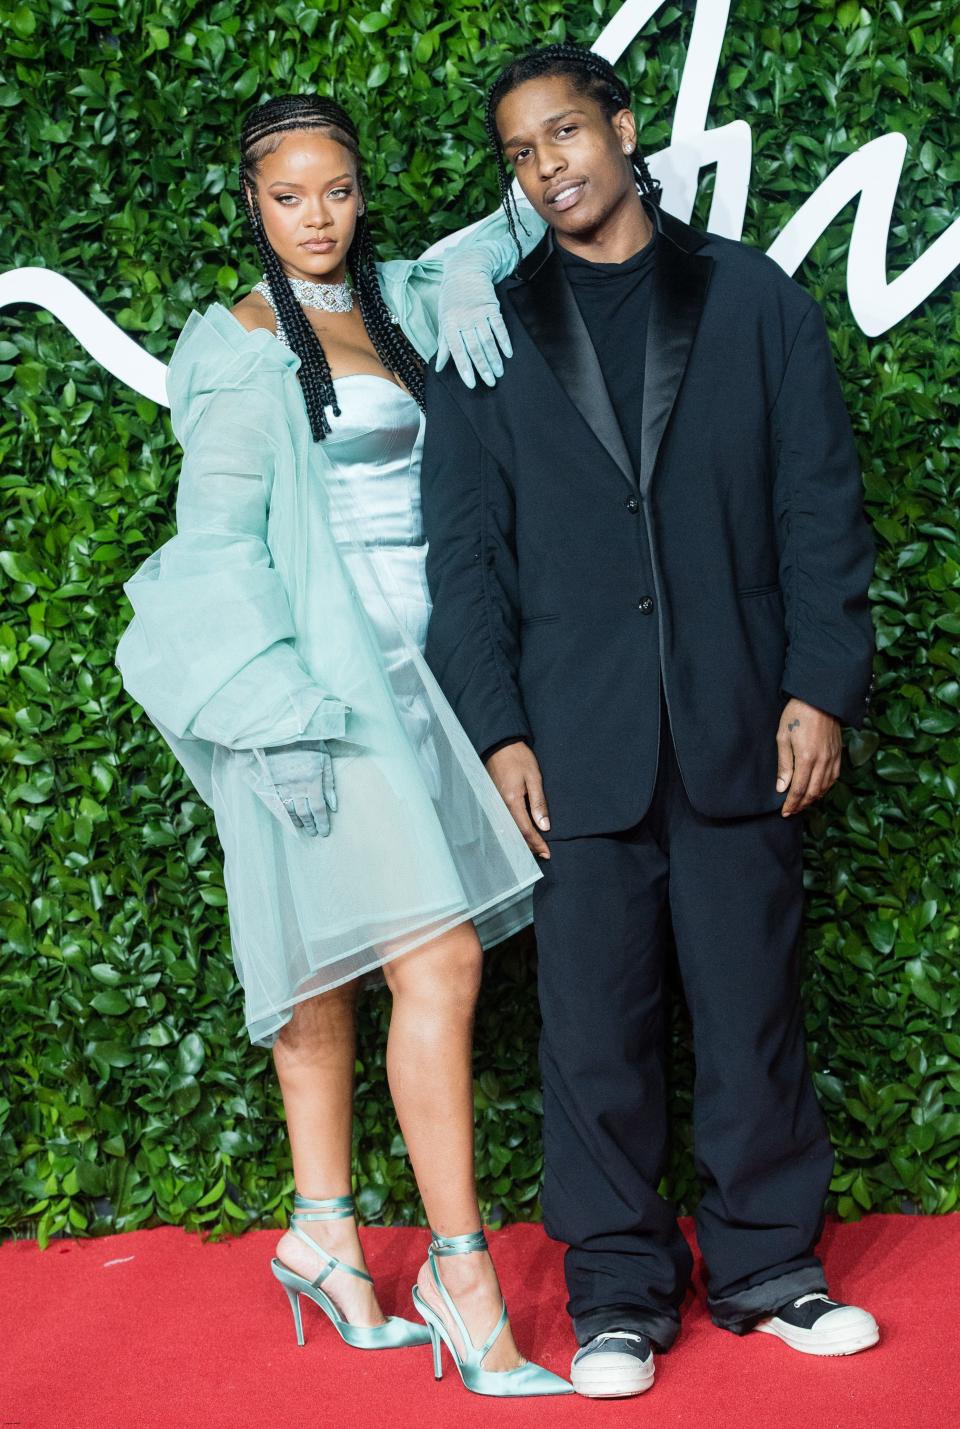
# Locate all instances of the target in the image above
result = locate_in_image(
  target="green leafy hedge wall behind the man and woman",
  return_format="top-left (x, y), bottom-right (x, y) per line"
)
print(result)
top-left (0, 0), bottom-right (960, 1240)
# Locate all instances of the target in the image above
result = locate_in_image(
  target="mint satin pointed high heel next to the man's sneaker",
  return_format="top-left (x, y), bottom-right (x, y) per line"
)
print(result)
top-left (413, 1230), bottom-right (573, 1399)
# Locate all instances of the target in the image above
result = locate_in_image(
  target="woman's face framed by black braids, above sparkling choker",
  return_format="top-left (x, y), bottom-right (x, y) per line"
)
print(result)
top-left (256, 129), bottom-right (363, 283)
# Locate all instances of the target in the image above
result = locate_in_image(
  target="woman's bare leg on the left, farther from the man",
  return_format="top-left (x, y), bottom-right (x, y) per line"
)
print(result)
top-left (273, 983), bottom-right (383, 1325)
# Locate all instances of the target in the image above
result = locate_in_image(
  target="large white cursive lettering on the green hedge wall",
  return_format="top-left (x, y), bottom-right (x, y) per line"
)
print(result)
top-left (0, 0), bottom-right (960, 406)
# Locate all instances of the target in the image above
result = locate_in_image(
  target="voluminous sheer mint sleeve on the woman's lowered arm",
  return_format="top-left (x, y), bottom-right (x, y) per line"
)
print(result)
top-left (117, 389), bottom-right (349, 749)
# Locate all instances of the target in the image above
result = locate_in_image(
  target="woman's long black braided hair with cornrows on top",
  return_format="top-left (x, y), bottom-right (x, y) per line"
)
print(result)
top-left (240, 94), bottom-right (424, 442)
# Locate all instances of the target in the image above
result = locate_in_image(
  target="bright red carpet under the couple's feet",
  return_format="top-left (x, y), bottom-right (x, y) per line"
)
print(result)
top-left (0, 1215), bottom-right (960, 1429)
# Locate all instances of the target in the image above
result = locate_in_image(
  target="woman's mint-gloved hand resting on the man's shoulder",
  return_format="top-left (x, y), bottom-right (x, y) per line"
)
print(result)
top-left (437, 244), bottom-right (513, 387)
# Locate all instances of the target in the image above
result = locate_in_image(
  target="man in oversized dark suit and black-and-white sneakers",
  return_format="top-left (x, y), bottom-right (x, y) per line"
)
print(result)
top-left (423, 46), bottom-right (879, 1396)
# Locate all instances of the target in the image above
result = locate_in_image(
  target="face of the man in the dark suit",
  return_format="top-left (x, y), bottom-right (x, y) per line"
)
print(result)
top-left (496, 74), bottom-right (636, 239)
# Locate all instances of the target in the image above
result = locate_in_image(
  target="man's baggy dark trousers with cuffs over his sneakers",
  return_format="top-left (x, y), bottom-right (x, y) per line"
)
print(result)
top-left (536, 717), bottom-right (833, 1349)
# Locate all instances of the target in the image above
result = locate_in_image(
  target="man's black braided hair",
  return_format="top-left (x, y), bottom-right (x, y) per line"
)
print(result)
top-left (484, 44), bottom-right (660, 256)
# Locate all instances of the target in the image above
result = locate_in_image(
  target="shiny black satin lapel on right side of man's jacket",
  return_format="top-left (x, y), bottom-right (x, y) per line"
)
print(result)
top-left (640, 232), bottom-right (713, 496)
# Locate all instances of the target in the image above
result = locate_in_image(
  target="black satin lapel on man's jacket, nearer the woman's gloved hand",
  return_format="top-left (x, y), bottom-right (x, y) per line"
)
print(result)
top-left (509, 246), bottom-right (637, 490)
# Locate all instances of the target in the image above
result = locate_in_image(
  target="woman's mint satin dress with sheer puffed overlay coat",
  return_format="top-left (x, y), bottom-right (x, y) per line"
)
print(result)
top-left (117, 220), bottom-right (540, 1046)
